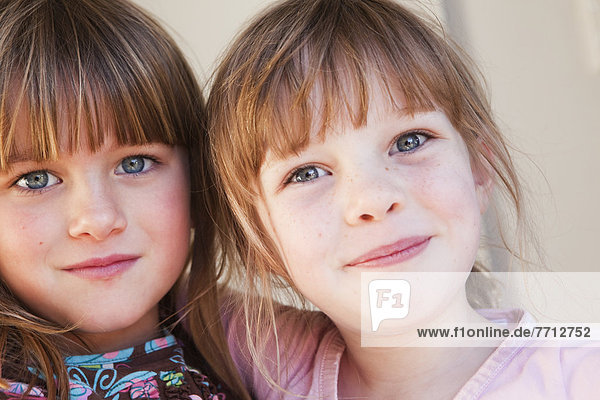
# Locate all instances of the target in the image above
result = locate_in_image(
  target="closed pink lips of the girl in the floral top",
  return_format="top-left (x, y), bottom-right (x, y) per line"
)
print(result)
top-left (64, 254), bottom-right (140, 279)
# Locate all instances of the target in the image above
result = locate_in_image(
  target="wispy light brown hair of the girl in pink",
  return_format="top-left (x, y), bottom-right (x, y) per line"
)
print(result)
top-left (208, 0), bottom-right (536, 390)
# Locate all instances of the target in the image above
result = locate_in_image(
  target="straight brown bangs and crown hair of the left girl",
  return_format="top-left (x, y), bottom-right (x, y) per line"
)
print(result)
top-left (0, 0), bottom-right (203, 169)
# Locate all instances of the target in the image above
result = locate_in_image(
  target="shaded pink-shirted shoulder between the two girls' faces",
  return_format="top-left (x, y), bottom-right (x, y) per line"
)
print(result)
top-left (224, 290), bottom-right (345, 399)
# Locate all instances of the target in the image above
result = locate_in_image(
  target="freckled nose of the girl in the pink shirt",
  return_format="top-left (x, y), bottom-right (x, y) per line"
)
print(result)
top-left (342, 168), bottom-right (406, 225)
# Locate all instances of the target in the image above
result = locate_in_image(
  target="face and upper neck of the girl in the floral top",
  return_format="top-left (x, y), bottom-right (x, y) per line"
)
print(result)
top-left (0, 109), bottom-right (190, 349)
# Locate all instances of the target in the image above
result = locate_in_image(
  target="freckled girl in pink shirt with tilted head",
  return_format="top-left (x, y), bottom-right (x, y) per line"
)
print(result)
top-left (208, 0), bottom-right (600, 399)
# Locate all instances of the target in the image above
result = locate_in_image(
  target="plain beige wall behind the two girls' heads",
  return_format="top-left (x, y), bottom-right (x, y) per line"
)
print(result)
top-left (136, 0), bottom-right (600, 271)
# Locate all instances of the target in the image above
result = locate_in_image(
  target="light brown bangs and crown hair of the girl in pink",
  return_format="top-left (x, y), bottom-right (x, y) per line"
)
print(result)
top-left (218, 0), bottom-right (472, 167)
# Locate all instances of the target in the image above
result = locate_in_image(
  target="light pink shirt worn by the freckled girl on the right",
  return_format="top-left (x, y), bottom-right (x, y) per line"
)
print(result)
top-left (225, 309), bottom-right (600, 400)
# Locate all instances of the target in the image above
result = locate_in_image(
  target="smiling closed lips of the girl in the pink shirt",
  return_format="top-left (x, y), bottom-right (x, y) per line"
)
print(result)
top-left (346, 236), bottom-right (431, 268)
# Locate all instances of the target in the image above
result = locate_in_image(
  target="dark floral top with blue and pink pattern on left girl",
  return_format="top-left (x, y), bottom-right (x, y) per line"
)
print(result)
top-left (0, 335), bottom-right (225, 400)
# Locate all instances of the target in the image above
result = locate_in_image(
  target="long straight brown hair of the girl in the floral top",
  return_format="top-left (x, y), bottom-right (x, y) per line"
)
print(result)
top-left (0, 0), bottom-right (245, 399)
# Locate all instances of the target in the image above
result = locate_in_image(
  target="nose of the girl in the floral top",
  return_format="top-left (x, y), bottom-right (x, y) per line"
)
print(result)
top-left (69, 181), bottom-right (127, 240)
